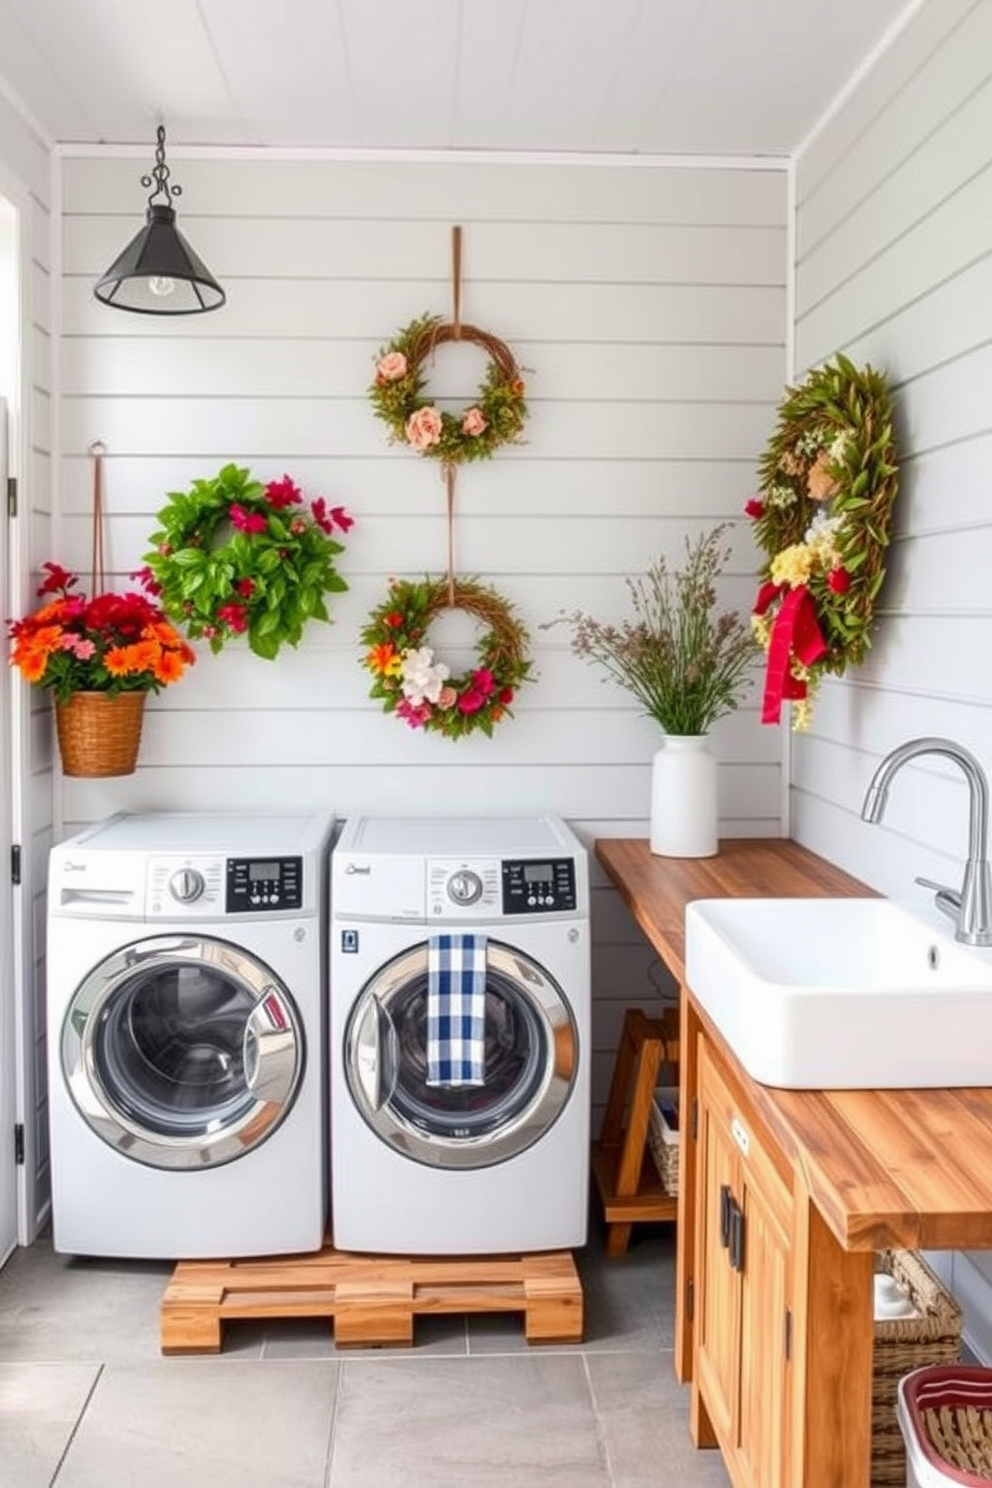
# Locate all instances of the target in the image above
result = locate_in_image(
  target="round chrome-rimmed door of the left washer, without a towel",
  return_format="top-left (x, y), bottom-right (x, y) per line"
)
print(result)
top-left (62, 936), bottom-right (305, 1168)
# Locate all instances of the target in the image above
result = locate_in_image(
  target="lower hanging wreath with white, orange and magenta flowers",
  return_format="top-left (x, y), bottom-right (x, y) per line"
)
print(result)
top-left (361, 577), bottom-right (531, 740)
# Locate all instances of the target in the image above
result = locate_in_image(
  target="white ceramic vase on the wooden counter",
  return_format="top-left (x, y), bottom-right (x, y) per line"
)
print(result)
top-left (651, 734), bottom-right (717, 857)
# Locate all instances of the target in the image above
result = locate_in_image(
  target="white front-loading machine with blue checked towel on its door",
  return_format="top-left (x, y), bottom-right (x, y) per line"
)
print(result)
top-left (330, 815), bottom-right (590, 1256)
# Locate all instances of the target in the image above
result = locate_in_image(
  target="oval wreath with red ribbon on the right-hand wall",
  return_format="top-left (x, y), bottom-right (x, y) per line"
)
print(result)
top-left (745, 356), bottom-right (898, 729)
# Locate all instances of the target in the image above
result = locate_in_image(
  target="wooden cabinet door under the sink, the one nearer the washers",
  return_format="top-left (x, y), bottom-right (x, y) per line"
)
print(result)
top-left (693, 1043), bottom-right (741, 1452)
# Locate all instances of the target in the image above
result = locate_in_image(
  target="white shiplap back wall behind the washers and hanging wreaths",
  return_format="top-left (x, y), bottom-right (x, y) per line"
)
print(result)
top-left (55, 155), bottom-right (787, 1148)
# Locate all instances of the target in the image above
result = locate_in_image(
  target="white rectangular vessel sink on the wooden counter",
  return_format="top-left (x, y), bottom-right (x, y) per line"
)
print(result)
top-left (686, 899), bottom-right (992, 1089)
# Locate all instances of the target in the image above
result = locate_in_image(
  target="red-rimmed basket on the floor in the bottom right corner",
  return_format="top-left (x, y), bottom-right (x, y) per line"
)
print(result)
top-left (895, 1364), bottom-right (992, 1488)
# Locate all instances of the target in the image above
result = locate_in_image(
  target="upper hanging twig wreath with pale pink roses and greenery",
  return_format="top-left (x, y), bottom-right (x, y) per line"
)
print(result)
top-left (369, 315), bottom-right (526, 466)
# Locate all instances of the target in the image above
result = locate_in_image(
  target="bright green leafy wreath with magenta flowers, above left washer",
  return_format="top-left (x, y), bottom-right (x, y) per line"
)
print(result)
top-left (143, 464), bottom-right (354, 661)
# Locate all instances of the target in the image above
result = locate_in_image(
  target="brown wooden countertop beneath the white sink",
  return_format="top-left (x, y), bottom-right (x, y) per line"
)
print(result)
top-left (595, 838), bottom-right (992, 1250)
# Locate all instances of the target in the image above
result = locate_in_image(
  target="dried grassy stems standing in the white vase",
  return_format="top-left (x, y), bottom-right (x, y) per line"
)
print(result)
top-left (543, 522), bottom-right (754, 735)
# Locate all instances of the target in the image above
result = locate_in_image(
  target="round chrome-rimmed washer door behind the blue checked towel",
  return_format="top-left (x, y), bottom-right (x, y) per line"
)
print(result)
top-left (344, 940), bottom-right (579, 1168)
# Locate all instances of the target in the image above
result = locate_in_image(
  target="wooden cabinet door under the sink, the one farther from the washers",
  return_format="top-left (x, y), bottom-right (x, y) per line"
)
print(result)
top-left (738, 1132), bottom-right (791, 1488)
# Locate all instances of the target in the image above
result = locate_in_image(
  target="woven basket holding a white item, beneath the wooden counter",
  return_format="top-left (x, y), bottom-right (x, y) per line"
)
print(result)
top-left (872, 1250), bottom-right (961, 1488)
